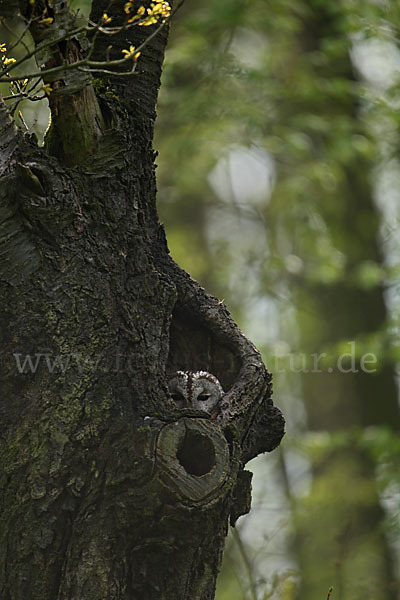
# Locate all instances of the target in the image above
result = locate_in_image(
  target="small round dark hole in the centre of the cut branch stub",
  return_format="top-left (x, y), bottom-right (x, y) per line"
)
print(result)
top-left (176, 431), bottom-right (215, 477)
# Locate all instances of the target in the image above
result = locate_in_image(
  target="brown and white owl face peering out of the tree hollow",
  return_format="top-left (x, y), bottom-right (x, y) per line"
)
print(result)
top-left (168, 371), bottom-right (224, 413)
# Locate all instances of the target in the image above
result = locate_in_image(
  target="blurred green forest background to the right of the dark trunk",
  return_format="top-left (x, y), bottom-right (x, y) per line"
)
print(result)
top-left (4, 0), bottom-right (400, 600)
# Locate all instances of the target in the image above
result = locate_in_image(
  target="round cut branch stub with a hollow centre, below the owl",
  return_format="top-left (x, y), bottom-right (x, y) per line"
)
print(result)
top-left (157, 418), bottom-right (229, 503)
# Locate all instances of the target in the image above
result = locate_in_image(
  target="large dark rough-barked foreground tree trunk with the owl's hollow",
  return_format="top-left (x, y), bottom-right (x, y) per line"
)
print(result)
top-left (0, 0), bottom-right (283, 600)
